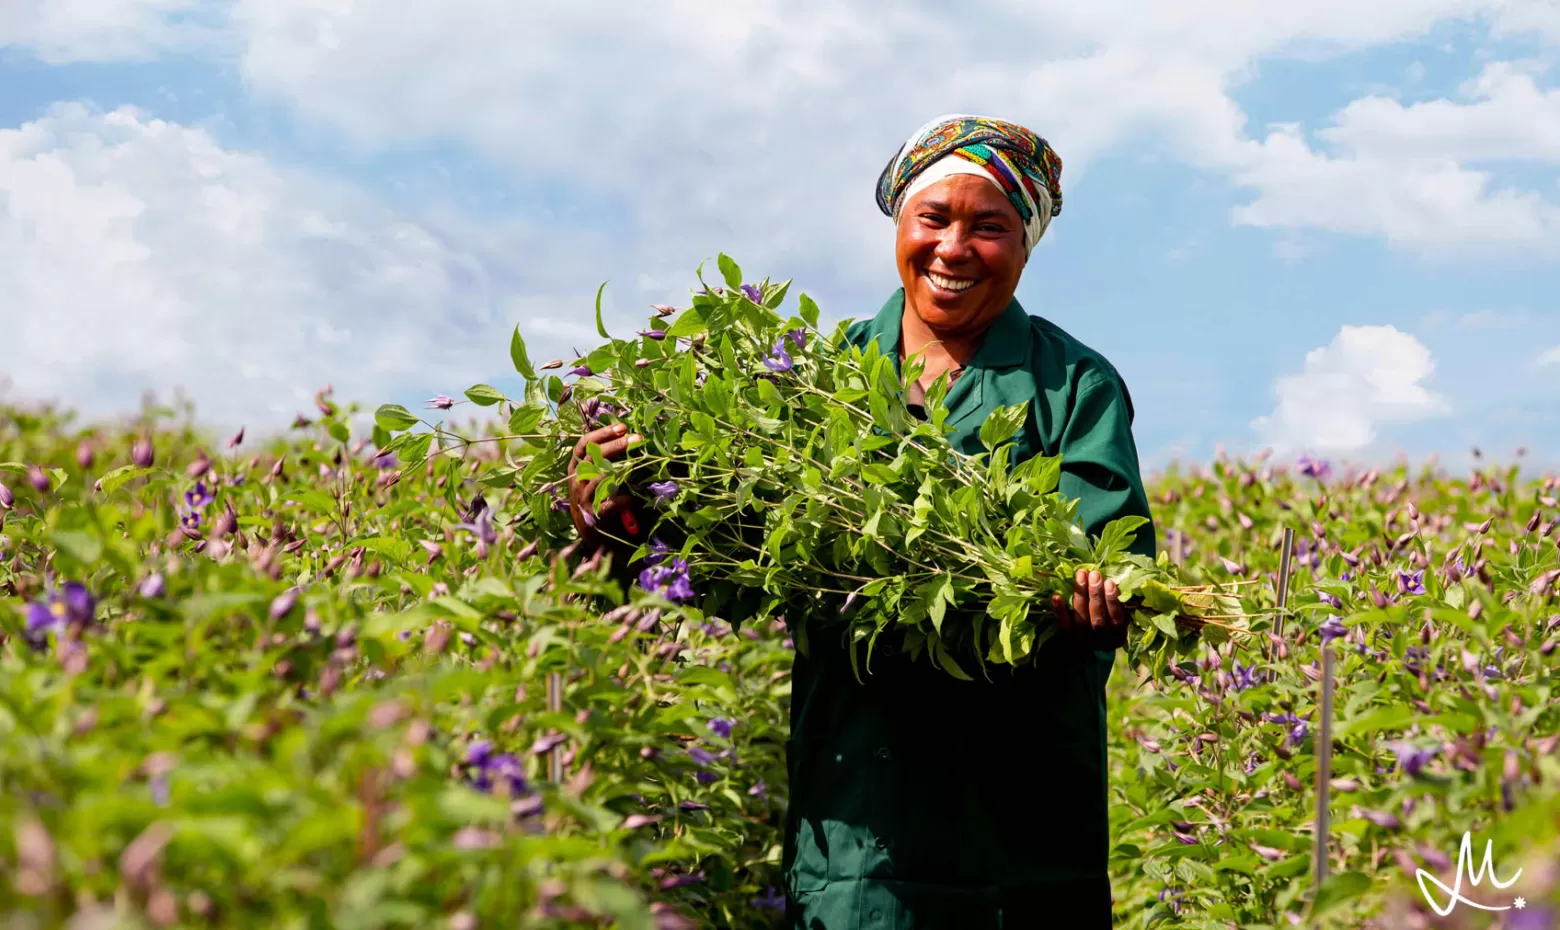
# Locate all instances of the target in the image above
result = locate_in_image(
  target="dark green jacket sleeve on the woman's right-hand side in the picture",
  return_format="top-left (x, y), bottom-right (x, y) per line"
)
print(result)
top-left (1058, 371), bottom-right (1158, 559)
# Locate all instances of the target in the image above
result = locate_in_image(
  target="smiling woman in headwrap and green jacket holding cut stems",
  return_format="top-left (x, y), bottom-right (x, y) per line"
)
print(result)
top-left (767, 115), bottom-right (1156, 930)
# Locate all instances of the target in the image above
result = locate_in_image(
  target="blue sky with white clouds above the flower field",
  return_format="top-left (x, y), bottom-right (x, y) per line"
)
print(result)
top-left (0, 0), bottom-right (1560, 468)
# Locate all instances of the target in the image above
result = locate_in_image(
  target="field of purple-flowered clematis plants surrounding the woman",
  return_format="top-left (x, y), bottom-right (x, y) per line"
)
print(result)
top-left (0, 265), bottom-right (1560, 930)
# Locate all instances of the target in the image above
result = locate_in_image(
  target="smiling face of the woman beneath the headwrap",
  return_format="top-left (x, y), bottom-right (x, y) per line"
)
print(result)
top-left (894, 175), bottom-right (1025, 337)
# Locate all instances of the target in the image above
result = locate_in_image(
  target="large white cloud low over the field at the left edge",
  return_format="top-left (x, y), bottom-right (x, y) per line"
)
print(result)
top-left (0, 105), bottom-right (620, 426)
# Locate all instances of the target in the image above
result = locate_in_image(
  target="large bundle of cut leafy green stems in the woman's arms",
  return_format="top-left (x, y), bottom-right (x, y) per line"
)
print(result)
top-left (473, 265), bottom-right (1245, 677)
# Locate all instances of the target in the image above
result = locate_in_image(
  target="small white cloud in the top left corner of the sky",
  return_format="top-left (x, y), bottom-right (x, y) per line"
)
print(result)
top-left (0, 0), bottom-right (220, 64)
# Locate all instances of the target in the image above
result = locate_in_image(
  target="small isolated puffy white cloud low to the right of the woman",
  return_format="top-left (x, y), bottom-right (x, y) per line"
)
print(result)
top-left (1251, 326), bottom-right (1449, 453)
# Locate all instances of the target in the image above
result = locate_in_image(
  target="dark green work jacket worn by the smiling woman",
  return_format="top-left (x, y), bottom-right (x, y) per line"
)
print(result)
top-left (785, 290), bottom-right (1154, 930)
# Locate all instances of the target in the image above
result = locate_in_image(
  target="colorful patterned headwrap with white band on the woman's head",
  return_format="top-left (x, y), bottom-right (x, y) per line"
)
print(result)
top-left (877, 114), bottom-right (1062, 257)
